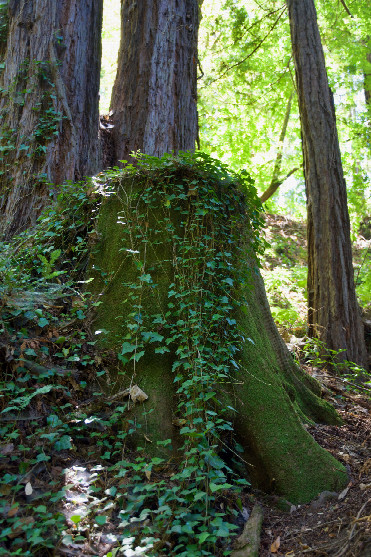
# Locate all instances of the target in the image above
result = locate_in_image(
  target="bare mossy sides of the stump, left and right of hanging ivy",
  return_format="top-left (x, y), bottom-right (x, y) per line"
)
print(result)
top-left (92, 162), bottom-right (348, 504)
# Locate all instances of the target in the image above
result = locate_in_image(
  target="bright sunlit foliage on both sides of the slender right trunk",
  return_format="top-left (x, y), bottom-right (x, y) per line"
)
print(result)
top-left (199, 0), bottom-right (371, 224)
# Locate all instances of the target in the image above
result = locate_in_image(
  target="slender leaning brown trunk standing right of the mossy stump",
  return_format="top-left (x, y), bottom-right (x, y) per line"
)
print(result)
top-left (287, 0), bottom-right (366, 366)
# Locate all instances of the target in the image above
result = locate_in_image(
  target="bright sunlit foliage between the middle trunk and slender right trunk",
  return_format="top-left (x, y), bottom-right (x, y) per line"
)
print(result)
top-left (199, 0), bottom-right (301, 202)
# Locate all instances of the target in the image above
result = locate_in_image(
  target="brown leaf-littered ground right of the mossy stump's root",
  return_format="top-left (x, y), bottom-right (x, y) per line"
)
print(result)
top-left (256, 369), bottom-right (371, 557)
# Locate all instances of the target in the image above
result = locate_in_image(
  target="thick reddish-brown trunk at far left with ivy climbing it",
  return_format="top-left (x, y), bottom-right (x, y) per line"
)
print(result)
top-left (0, 0), bottom-right (103, 236)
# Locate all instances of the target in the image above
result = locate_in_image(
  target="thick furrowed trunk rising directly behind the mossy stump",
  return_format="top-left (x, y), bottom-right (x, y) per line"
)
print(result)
top-left (111, 0), bottom-right (199, 160)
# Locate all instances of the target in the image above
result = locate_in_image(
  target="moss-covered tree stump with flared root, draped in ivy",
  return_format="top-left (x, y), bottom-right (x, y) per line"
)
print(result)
top-left (92, 163), bottom-right (347, 502)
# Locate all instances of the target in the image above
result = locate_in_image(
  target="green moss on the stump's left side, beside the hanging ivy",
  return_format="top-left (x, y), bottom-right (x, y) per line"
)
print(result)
top-left (89, 183), bottom-right (177, 445)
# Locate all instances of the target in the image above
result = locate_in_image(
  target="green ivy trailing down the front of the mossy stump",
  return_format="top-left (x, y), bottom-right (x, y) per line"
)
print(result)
top-left (92, 153), bottom-right (261, 557)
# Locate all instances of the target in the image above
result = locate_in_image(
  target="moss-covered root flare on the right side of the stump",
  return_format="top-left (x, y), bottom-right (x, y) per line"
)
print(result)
top-left (230, 250), bottom-right (347, 503)
